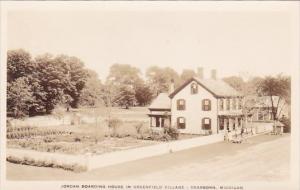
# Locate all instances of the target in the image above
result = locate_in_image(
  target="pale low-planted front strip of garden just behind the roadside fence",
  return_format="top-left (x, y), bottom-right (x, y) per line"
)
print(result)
top-left (7, 136), bottom-right (159, 154)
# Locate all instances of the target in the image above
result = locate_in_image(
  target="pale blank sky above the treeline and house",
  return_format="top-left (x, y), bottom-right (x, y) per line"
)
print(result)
top-left (7, 6), bottom-right (294, 80)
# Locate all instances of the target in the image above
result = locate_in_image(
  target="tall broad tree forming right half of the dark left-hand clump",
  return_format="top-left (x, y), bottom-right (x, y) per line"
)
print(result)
top-left (35, 54), bottom-right (87, 113)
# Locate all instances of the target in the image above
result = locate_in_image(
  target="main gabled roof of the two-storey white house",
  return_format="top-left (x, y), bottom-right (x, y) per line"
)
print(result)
top-left (169, 77), bottom-right (243, 98)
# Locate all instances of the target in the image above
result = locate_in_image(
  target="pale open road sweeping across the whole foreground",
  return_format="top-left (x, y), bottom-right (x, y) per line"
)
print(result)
top-left (7, 135), bottom-right (290, 181)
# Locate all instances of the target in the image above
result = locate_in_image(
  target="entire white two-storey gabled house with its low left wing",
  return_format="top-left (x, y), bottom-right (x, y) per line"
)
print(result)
top-left (149, 71), bottom-right (243, 135)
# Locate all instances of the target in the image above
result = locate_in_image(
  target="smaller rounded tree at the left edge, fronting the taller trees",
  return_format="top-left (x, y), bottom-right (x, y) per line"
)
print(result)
top-left (7, 77), bottom-right (35, 118)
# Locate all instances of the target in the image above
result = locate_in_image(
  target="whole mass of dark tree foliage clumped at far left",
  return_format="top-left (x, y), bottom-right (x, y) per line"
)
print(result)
top-left (7, 49), bottom-right (88, 115)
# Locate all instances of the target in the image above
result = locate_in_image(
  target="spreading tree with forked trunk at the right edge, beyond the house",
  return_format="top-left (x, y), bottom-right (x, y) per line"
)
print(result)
top-left (257, 75), bottom-right (291, 129)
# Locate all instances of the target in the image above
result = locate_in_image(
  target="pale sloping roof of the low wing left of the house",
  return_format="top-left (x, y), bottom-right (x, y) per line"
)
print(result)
top-left (149, 93), bottom-right (171, 110)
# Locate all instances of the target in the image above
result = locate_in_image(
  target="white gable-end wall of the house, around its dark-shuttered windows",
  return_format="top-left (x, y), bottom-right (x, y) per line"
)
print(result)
top-left (171, 81), bottom-right (217, 134)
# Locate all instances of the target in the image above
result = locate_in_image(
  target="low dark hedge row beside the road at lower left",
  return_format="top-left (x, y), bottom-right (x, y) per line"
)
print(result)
top-left (6, 156), bottom-right (87, 172)
